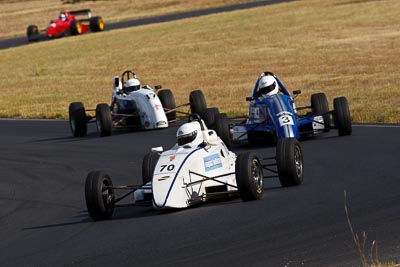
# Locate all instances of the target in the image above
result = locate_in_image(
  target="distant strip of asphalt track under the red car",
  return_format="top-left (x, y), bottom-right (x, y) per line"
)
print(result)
top-left (0, 0), bottom-right (291, 50)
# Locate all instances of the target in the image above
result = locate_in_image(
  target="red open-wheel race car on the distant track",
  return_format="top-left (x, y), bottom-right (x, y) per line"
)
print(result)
top-left (26, 9), bottom-right (104, 41)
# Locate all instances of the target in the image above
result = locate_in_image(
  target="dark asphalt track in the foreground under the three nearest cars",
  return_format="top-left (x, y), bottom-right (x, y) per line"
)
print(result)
top-left (0, 120), bottom-right (400, 266)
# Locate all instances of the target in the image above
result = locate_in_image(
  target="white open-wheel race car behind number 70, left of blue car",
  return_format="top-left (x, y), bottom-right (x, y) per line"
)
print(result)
top-left (69, 70), bottom-right (207, 137)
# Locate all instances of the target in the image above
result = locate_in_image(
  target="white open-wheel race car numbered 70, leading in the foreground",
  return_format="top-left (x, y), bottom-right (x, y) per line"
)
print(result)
top-left (85, 114), bottom-right (303, 220)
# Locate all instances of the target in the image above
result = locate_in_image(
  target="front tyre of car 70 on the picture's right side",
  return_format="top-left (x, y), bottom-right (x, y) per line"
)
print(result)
top-left (235, 152), bottom-right (264, 201)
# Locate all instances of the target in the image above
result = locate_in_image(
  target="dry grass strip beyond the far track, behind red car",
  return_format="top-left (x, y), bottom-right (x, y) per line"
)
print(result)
top-left (0, 0), bottom-right (255, 38)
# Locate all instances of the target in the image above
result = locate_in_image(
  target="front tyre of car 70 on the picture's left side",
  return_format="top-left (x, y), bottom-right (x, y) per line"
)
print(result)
top-left (85, 171), bottom-right (115, 221)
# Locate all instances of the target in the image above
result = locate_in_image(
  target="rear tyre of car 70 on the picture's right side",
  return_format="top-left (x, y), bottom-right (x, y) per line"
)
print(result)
top-left (276, 138), bottom-right (304, 187)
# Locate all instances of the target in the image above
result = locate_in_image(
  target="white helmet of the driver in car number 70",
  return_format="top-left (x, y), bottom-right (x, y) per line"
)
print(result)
top-left (176, 121), bottom-right (204, 148)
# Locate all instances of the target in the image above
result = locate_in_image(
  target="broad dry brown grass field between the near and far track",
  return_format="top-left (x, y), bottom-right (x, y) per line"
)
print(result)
top-left (0, 0), bottom-right (400, 123)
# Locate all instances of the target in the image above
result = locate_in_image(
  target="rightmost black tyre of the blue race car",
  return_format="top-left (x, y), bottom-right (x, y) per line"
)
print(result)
top-left (333, 96), bottom-right (352, 136)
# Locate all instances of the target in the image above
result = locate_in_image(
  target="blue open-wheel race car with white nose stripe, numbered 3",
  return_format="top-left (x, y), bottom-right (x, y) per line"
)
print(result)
top-left (205, 72), bottom-right (352, 147)
